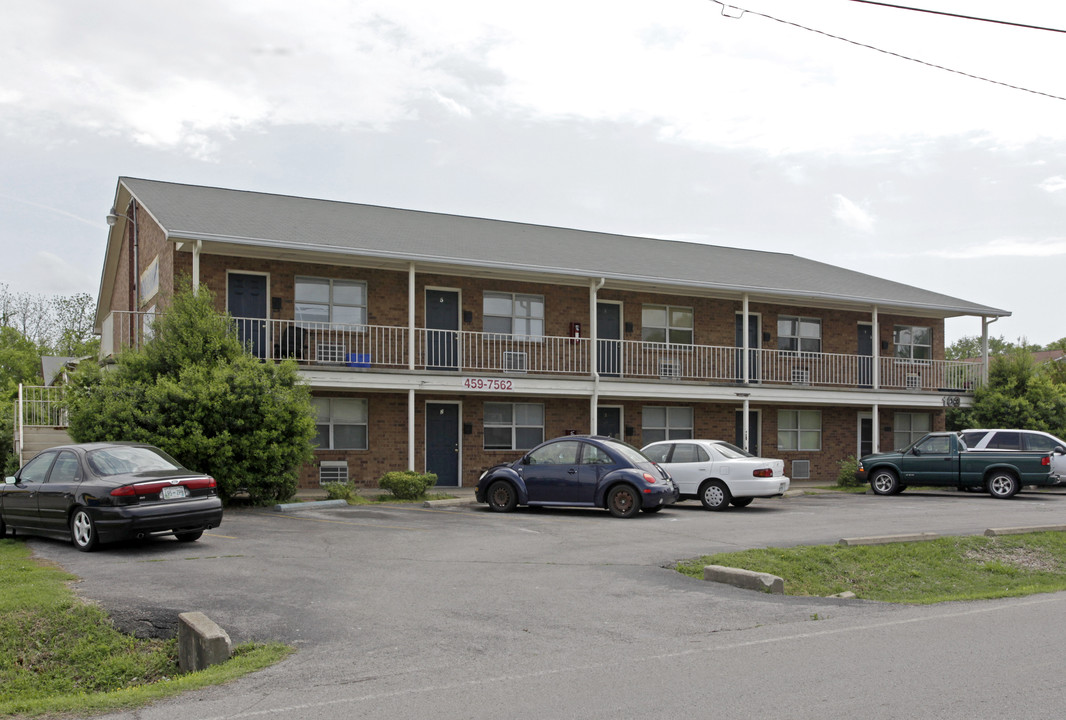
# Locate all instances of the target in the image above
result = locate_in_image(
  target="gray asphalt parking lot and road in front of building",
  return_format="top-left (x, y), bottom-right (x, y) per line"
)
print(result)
top-left (22, 491), bottom-right (1066, 720)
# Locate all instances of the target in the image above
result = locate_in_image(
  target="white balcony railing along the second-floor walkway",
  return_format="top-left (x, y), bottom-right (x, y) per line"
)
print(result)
top-left (101, 311), bottom-right (983, 394)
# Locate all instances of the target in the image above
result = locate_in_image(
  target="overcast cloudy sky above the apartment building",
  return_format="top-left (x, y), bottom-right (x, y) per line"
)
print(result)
top-left (0, 0), bottom-right (1066, 345)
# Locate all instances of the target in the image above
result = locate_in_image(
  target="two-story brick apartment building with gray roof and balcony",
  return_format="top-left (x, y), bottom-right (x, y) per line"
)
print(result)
top-left (97, 178), bottom-right (1008, 487)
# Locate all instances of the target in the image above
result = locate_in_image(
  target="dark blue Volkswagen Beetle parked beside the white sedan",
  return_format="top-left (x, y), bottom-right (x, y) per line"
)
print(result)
top-left (475, 435), bottom-right (678, 517)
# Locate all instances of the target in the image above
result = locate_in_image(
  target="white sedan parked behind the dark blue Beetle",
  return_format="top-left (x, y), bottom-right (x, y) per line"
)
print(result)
top-left (641, 439), bottom-right (790, 510)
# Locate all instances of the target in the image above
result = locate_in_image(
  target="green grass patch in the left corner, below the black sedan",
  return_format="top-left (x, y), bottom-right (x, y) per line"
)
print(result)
top-left (0, 540), bottom-right (291, 717)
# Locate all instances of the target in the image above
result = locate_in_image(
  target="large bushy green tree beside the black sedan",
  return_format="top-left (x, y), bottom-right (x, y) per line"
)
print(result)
top-left (68, 288), bottom-right (316, 503)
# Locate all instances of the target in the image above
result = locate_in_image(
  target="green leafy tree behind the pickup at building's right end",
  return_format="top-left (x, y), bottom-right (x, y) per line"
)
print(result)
top-left (948, 351), bottom-right (1066, 437)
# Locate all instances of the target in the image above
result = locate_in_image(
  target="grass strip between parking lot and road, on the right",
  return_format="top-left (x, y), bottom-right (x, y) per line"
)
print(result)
top-left (676, 532), bottom-right (1066, 605)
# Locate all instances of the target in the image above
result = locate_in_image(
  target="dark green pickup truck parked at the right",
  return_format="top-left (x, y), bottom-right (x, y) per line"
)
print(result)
top-left (855, 432), bottom-right (1059, 498)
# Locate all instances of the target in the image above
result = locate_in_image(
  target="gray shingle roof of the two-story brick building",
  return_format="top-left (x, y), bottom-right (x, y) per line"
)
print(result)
top-left (119, 178), bottom-right (1010, 316)
